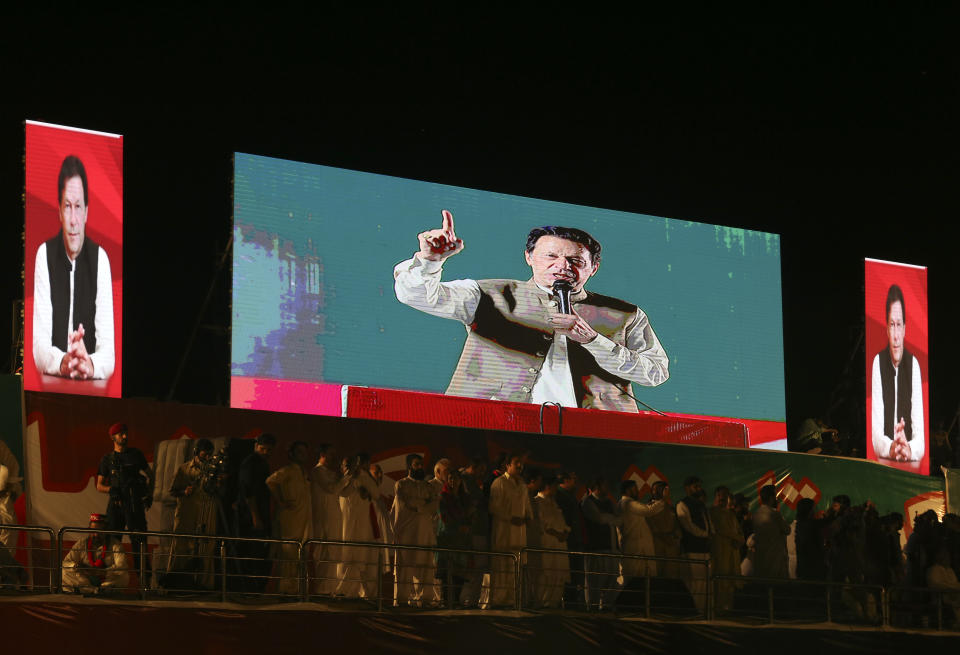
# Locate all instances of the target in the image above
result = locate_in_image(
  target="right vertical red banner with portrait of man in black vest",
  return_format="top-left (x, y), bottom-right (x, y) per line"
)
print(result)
top-left (864, 259), bottom-right (930, 474)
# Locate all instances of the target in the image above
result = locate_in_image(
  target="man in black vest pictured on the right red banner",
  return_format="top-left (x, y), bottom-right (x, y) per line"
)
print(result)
top-left (870, 284), bottom-right (926, 462)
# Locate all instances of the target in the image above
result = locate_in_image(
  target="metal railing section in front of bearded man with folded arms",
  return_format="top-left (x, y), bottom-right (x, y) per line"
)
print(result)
top-left (301, 539), bottom-right (521, 610)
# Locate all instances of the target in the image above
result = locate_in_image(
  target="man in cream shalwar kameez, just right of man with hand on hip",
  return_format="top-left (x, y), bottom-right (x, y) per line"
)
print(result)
top-left (309, 444), bottom-right (344, 596)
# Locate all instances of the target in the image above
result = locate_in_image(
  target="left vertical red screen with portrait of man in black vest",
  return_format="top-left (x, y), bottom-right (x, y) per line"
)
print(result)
top-left (23, 121), bottom-right (123, 398)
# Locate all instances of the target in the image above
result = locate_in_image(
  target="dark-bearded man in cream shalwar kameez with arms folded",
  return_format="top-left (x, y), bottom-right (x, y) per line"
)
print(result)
top-left (391, 453), bottom-right (440, 605)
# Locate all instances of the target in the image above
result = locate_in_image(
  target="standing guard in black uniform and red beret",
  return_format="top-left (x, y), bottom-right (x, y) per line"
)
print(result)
top-left (97, 423), bottom-right (153, 584)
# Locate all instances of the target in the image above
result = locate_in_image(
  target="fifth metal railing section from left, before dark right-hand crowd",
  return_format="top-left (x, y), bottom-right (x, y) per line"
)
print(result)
top-left (711, 575), bottom-right (888, 625)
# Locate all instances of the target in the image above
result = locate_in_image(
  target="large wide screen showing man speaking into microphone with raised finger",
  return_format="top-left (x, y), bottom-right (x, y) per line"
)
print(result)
top-left (231, 153), bottom-right (785, 439)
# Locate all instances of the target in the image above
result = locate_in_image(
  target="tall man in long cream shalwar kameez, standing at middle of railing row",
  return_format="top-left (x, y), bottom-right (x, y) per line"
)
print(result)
top-left (490, 454), bottom-right (533, 607)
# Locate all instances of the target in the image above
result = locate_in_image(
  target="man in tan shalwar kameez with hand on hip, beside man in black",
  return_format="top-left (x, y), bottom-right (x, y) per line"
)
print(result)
top-left (267, 441), bottom-right (313, 595)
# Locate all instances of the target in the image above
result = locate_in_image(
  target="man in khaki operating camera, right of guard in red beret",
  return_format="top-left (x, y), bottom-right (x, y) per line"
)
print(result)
top-left (165, 439), bottom-right (223, 589)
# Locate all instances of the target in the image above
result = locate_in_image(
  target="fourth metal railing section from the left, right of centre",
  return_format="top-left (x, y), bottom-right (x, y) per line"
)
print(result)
top-left (521, 548), bottom-right (712, 618)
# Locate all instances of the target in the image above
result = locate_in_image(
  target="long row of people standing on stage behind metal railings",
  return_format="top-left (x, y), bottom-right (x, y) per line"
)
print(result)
top-left (16, 424), bottom-right (960, 621)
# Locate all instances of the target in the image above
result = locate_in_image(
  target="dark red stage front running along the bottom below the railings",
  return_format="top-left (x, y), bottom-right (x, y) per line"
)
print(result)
top-left (0, 595), bottom-right (960, 655)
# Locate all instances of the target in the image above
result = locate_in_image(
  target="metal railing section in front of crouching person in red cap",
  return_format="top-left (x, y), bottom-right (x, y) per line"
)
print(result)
top-left (51, 527), bottom-right (304, 601)
